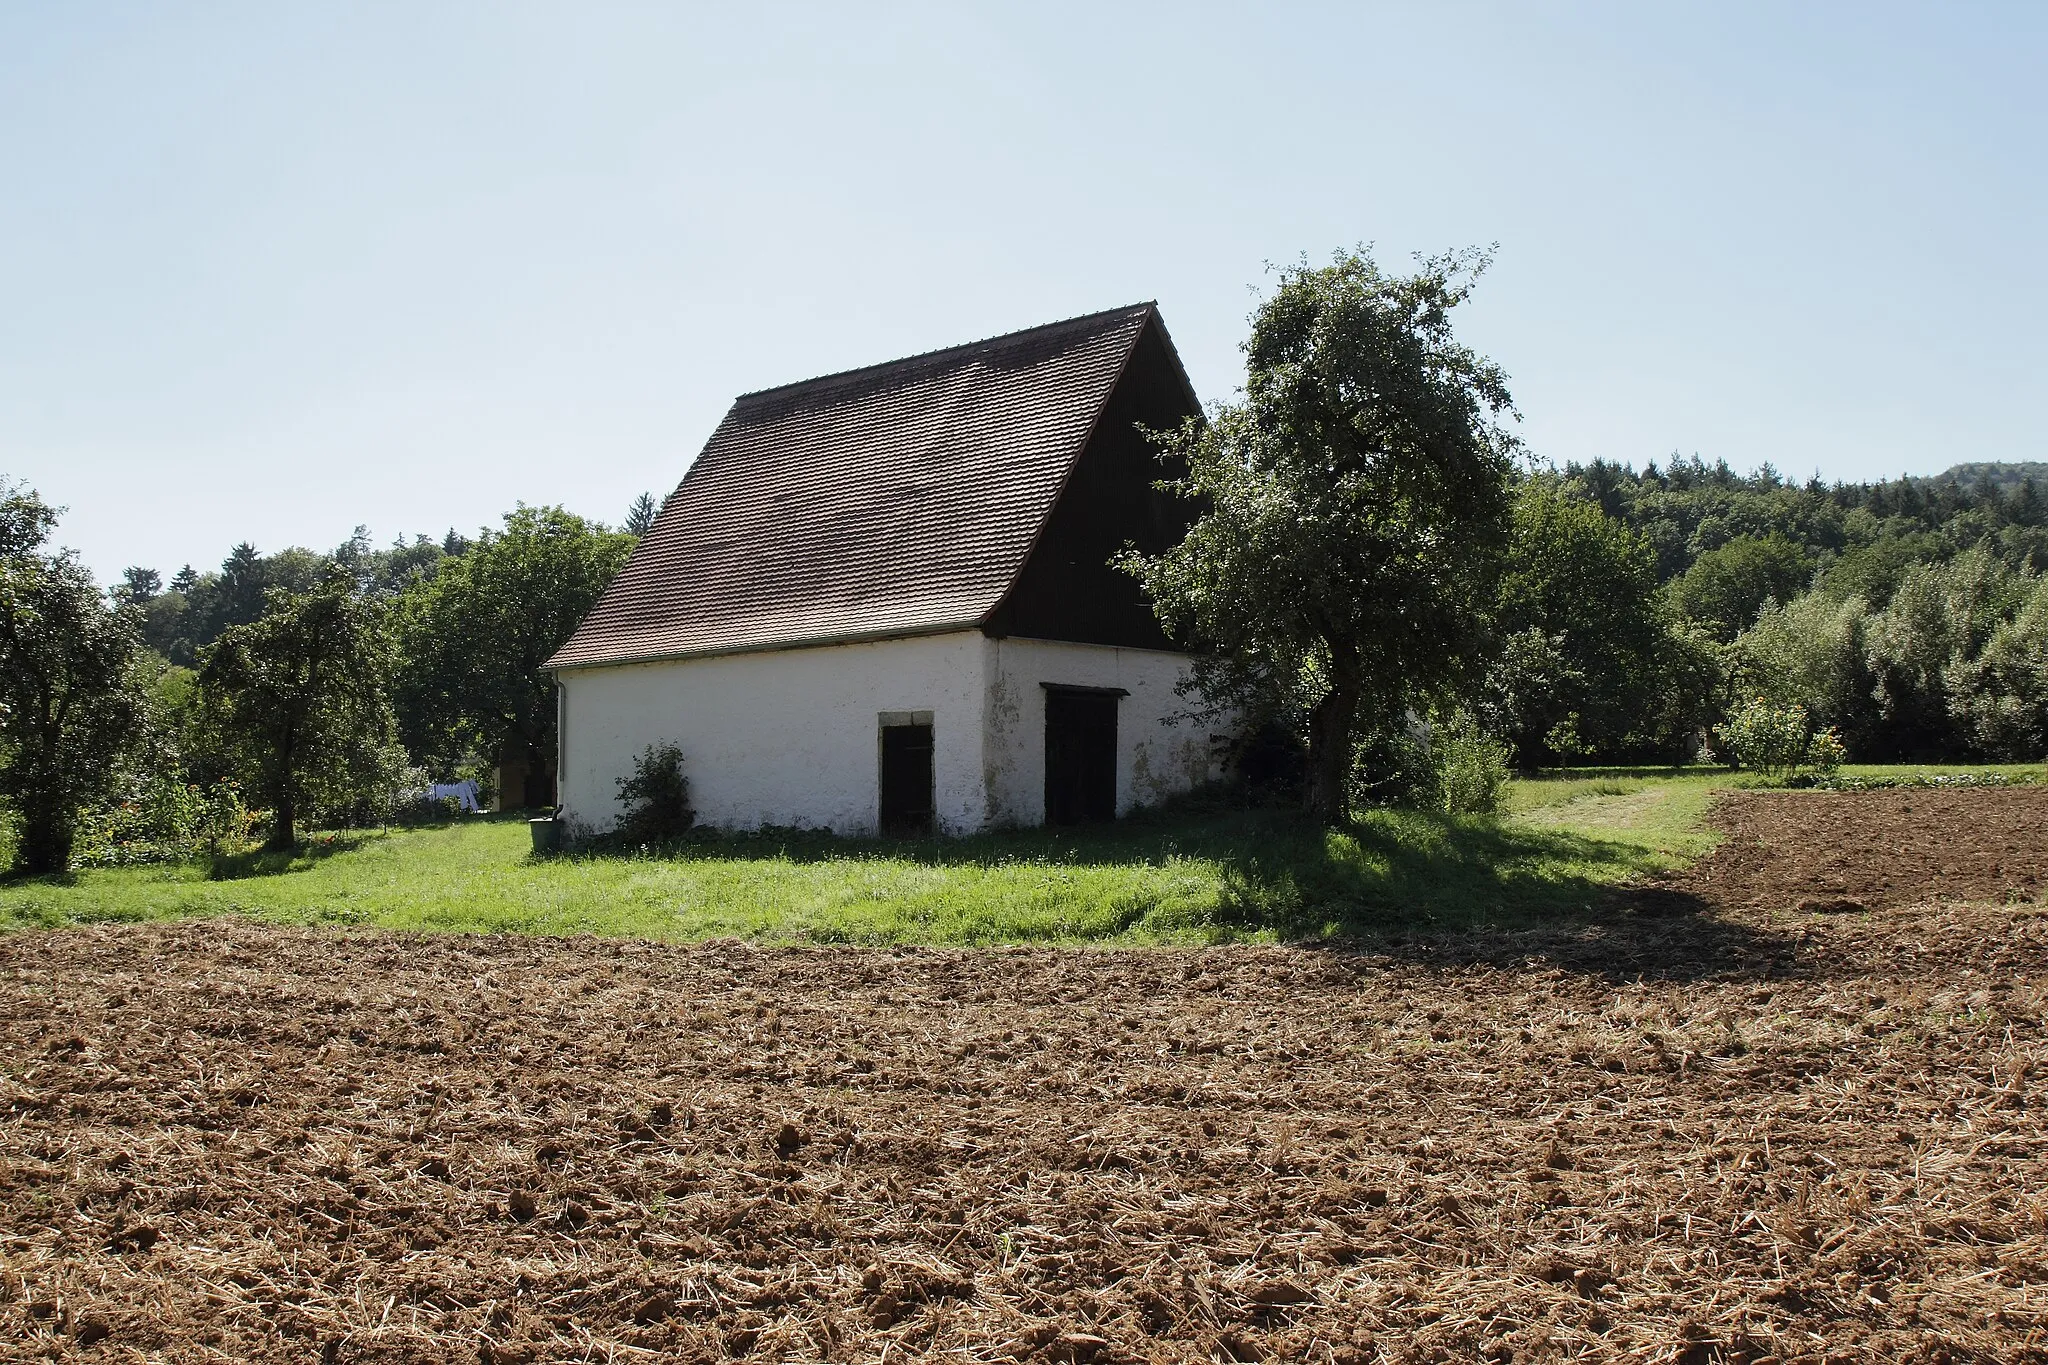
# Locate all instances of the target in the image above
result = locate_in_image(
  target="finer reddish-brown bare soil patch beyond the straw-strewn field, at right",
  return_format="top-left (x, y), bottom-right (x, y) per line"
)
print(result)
top-left (1679, 786), bottom-right (2048, 911)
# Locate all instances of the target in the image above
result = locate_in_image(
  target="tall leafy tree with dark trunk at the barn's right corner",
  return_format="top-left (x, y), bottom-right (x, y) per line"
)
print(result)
top-left (1122, 250), bottom-right (1518, 821)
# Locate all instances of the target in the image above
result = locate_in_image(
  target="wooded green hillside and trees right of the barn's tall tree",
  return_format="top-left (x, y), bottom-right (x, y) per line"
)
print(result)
top-left (1515, 460), bottom-right (2048, 763)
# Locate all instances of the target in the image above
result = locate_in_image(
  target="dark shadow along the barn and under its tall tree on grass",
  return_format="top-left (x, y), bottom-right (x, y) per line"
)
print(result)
top-left (571, 806), bottom-right (1790, 980)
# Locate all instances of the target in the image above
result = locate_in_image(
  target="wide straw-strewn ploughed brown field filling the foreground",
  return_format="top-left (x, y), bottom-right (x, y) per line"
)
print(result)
top-left (0, 907), bottom-right (2048, 1363)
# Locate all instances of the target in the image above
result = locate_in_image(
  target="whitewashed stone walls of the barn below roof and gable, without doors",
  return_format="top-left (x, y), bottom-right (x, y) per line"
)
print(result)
top-left (559, 630), bottom-right (1212, 835)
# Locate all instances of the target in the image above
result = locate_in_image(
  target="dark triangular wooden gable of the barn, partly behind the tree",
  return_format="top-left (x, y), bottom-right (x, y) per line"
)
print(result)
top-left (983, 311), bottom-right (1200, 649)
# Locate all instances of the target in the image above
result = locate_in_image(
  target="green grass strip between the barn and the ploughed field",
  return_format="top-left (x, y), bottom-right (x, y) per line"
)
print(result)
top-left (0, 767), bottom-right (2040, 943)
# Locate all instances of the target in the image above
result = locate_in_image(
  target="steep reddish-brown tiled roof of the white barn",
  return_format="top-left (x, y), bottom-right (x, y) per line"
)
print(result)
top-left (549, 303), bottom-right (1153, 667)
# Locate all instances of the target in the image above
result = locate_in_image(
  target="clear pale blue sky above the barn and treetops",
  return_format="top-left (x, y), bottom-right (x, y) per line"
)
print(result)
top-left (0, 0), bottom-right (2048, 579)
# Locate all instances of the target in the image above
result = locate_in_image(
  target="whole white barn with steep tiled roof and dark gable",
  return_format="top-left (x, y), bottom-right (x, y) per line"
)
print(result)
top-left (549, 303), bottom-right (1214, 835)
